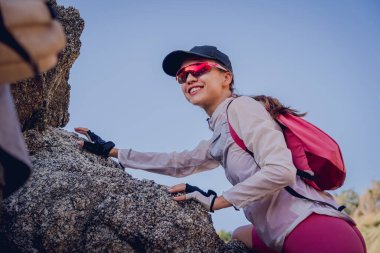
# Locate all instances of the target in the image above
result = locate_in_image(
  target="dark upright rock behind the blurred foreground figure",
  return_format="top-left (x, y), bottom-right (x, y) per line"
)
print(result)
top-left (12, 0), bottom-right (84, 131)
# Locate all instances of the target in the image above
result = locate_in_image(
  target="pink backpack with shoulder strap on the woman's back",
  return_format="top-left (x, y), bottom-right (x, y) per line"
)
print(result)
top-left (227, 100), bottom-right (346, 191)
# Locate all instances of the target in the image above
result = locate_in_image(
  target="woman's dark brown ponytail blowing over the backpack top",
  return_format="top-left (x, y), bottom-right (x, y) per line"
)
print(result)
top-left (234, 94), bottom-right (307, 119)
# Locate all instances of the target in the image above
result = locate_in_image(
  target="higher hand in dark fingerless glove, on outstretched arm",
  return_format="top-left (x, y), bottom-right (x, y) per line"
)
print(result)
top-left (74, 127), bottom-right (117, 157)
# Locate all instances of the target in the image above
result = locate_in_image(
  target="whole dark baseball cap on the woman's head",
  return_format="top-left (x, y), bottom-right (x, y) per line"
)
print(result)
top-left (162, 46), bottom-right (232, 77)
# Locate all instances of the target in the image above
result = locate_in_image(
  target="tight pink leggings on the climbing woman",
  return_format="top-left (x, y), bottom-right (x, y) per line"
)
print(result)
top-left (252, 213), bottom-right (367, 253)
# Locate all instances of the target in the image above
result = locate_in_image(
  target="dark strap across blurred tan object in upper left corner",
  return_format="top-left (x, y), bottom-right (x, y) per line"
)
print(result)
top-left (0, 13), bottom-right (39, 76)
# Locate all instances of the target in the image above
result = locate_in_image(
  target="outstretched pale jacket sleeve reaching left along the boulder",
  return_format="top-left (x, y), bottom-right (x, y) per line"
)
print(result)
top-left (118, 140), bottom-right (219, 177)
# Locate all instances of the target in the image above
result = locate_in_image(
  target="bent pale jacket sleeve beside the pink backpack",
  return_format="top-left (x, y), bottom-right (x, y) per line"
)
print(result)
top-left (223, 97), bottom-right (297, 208)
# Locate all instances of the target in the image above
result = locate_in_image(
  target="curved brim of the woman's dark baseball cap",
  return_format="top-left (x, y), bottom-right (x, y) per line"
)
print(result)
top-left (162, 50), bottom-right (217, 77)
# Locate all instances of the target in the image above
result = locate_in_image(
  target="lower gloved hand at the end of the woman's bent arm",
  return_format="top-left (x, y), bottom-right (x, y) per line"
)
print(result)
top-left (169, 184), bottom-right (217, 212)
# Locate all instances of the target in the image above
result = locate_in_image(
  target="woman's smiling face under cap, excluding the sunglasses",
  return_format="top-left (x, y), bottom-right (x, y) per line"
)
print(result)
top-left (181, 59), bottom-right (232, 116)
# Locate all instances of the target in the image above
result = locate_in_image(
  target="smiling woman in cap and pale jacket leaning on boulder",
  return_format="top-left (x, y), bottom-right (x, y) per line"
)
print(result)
top-left (75, 46), bottom-right (365, 253)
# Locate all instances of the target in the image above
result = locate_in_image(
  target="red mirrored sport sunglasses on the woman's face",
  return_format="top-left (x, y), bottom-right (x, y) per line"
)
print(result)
top-left (176, 62), bottom-right (228, 84)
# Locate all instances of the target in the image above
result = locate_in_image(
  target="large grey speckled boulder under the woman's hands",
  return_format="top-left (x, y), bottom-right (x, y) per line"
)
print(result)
top-left (0, 127), bottom-right (252, 252)
